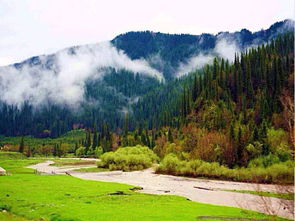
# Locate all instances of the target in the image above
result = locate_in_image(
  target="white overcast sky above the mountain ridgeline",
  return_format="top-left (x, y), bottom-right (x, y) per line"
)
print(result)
top-left (0, 0), bottom-right (294, 65)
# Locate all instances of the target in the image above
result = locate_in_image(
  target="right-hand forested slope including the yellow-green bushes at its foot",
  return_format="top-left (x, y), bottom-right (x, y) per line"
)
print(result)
top-left (116, 33), bottom-right (294, 183)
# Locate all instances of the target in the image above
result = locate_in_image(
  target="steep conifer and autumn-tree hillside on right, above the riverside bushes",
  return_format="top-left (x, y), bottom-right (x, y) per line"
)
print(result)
top-left (150, 33), bottom-right (294, 171)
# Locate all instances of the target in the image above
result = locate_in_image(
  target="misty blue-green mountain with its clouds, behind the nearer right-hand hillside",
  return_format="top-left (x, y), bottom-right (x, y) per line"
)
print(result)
top-left (0, 20), bottom-right (294, 137)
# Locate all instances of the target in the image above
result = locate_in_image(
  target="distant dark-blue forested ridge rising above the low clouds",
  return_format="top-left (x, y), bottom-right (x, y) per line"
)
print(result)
top-left (112, 20), bottom-right (294, 79)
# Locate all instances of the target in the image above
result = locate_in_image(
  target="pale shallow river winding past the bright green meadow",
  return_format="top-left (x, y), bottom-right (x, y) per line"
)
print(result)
top-left (30, 161), bottom-right (293, 219)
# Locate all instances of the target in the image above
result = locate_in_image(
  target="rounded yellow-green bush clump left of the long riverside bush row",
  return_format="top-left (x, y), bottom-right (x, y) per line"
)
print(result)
top-left (97, 145), bottom-right (158, 171)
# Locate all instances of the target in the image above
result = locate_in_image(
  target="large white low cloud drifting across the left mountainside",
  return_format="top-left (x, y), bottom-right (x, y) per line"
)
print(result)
top-left (0, 42), bottom-right (164, 106)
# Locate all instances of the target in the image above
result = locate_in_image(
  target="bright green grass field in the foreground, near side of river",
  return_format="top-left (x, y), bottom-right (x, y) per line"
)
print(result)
top-left (0, 155), bottom-right (290, 221)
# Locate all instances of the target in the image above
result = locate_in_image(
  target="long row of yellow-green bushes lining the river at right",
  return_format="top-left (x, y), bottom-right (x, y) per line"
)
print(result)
top-left (156, 154), bottom-right (295, 184)
